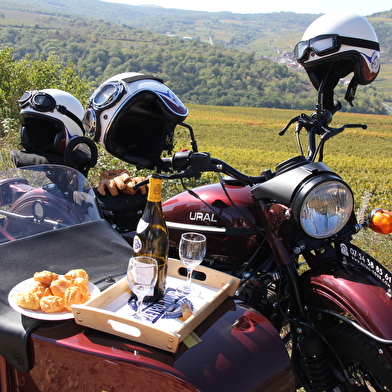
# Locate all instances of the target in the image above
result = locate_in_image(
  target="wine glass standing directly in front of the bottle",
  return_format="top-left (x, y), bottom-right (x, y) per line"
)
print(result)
top-left (127, 256), bottom-right (158, 320)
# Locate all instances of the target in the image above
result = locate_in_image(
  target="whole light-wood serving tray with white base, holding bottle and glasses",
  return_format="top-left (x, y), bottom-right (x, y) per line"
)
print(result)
top-left (72, 259), bottom-right (240, 352)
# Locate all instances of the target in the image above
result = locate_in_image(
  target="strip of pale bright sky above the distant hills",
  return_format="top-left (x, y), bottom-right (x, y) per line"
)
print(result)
top-left (105, 0), bottom-right (392, 16)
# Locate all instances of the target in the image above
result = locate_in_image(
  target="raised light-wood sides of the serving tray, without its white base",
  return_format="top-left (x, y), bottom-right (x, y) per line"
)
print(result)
top-left (72, 259), bottom-right (240, 352)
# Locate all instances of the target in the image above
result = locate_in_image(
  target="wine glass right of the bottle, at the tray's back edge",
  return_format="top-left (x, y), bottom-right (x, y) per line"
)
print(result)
top-left (177, 233), bottom-right (207, 296)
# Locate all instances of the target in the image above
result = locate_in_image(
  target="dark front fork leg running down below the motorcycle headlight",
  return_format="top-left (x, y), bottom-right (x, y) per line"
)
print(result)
top-left (259, 201), bottom-right (364, 392)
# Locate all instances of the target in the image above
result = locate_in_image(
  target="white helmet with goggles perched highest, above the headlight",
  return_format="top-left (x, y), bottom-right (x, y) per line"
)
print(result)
top-left (294, 12), bottom-right (380, 105)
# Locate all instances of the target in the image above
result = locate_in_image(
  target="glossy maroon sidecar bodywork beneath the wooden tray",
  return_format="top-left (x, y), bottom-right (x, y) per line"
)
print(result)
top-left (0, 299), bottom-right (295, 392)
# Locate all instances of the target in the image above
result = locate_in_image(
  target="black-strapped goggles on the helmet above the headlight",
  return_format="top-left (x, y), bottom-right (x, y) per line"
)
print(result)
top-left (294, 34), bottom-right (380, 63)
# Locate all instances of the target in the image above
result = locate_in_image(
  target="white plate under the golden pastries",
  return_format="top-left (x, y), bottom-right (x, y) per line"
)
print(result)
top-left (8, 278), bottom-right (101, 321)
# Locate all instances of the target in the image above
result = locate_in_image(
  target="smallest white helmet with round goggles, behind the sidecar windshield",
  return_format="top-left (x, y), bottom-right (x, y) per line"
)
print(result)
top-left (18, 89), bottom-right (84, 155)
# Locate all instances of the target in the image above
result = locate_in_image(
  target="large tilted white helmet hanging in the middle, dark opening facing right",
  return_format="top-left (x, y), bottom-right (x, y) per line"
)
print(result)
top-left (83, 72), bottom-right (188, 170)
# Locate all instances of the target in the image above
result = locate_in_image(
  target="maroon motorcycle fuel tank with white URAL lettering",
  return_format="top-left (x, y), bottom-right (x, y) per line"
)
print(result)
top-left (162, 183), bottom-right (262, 262)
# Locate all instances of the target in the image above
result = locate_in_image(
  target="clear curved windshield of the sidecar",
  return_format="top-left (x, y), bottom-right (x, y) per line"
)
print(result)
top-left (0, 165), bottom-right (101, 243)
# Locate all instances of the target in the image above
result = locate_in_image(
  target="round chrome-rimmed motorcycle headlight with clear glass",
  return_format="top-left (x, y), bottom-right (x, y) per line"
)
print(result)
top-left (292, 176), bottom-right (354, 239)
